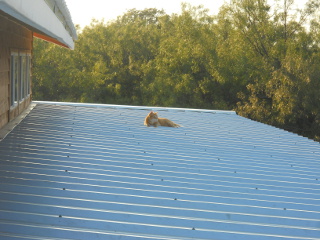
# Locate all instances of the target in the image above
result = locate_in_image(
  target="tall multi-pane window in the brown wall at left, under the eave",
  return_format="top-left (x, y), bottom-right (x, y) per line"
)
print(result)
top-left (10, 52), bottom-right (31, 107)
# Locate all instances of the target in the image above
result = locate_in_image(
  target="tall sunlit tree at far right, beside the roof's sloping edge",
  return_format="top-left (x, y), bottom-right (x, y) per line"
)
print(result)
top-left (231, 0), bottom-right (319, 138)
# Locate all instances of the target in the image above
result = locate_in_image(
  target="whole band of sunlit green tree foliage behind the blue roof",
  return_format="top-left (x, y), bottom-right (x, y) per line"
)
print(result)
top-left (33, 0), bottom-right (320, 140)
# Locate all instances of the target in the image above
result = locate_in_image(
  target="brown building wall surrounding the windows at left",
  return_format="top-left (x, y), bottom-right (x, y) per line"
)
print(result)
top-left (0, 11), bottom-right (33, 128)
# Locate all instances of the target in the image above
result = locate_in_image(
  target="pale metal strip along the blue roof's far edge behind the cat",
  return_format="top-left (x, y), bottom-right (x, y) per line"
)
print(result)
top-left (32, 101), bottom-right (236, 114)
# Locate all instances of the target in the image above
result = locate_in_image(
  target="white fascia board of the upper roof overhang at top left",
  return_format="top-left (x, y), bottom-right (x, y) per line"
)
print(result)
top-left (0, 0), bottom-right (74, 49)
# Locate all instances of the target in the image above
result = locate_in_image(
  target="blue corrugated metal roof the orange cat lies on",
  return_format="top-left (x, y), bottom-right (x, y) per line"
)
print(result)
top-left (0, 102), bottom-right (320, 240)
